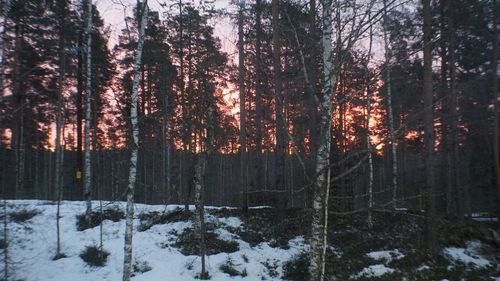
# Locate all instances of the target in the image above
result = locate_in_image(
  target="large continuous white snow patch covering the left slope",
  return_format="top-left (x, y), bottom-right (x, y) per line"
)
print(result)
top-left (2, 200), bottom-right (308, 281)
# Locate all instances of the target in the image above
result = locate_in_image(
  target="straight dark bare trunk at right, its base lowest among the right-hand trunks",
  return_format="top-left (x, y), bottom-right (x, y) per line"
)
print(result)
top-left (422, 0), bottom-right (438, 252)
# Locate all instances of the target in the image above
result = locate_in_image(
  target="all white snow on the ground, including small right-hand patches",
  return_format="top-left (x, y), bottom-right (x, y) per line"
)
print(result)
top-left (0, 200), bottom-right (500, 281)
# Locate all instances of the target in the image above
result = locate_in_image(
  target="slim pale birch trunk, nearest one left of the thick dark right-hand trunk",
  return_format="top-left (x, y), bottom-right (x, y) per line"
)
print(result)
top-left (382, 0), bottom-right (398, 209)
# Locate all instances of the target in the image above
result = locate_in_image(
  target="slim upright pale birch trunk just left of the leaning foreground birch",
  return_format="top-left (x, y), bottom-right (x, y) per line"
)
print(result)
top-left (83, 0), bottom-right (92, 225)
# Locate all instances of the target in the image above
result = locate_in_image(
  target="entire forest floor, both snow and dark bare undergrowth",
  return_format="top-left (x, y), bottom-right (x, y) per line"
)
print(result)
top-left (0, 200), bottom-right (500, 281)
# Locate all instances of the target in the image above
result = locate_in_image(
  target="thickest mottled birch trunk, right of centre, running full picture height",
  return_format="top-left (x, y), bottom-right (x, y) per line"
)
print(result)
top-left (310, 0), bottom-right (335, 281)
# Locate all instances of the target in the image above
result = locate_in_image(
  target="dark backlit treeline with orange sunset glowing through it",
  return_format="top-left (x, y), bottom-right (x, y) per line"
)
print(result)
top-left (1, 0), bottom-right (496, 212)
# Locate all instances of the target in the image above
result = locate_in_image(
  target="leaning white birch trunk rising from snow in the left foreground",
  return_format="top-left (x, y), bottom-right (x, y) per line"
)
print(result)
top-left (123, 0), bottom-right (148, 281)
